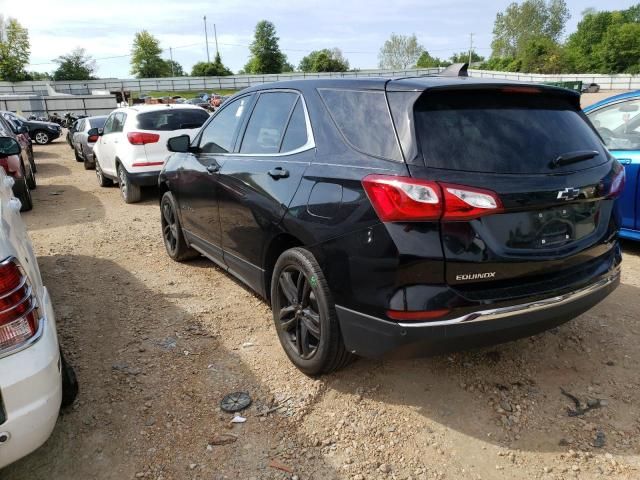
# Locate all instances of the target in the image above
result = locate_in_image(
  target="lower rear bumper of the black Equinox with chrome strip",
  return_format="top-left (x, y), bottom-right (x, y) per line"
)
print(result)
top-left (336, 267), bottom-right (620, 357)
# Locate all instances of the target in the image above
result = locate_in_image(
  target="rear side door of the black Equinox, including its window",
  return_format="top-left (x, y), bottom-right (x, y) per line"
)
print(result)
top-left (219, 90), bottom-right (315, 294)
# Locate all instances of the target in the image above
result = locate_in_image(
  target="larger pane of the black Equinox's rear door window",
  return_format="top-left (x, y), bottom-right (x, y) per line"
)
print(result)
top-left (240, 92), bottom-right (298, 154)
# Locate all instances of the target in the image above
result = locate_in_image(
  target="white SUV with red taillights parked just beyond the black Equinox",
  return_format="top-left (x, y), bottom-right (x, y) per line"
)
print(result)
top-left (89, 104), bottom-right (209, 203)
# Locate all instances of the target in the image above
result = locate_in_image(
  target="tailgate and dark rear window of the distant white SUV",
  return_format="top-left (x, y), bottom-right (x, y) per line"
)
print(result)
top-left (127, 107), bottom-right (209, 169)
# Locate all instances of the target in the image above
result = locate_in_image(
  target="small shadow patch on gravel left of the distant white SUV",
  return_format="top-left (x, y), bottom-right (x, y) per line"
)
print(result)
top-left (22, 185), bottom-right (105, 231)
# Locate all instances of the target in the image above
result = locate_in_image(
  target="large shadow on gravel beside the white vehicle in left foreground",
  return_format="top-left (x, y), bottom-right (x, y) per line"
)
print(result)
top-left (0, 255), bottom-right (337, 480)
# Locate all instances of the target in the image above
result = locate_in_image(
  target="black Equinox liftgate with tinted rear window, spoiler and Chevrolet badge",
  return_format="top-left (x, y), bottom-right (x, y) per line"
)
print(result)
top-left (392, 85), bottom-right (624, 300)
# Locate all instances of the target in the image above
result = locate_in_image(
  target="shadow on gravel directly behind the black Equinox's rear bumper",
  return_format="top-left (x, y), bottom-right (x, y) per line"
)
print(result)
top-left (328, 285), bottom-right (640, 454)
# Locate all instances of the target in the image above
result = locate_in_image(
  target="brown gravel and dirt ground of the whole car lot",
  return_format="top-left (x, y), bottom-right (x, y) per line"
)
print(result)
top-left (0, 135), bottom-right (640, 480)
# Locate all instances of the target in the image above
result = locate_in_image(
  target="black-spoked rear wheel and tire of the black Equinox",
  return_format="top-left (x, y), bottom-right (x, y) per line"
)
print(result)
top-left (271, 248), bottom-right (355, 376)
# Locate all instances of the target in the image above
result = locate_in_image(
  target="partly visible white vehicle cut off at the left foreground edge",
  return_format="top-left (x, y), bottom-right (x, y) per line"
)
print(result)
top-left (0, 137), bottom-right (77, 468)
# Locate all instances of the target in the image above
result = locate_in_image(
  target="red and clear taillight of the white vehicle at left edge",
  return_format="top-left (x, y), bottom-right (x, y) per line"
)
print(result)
top-left (0, 258), bottom-right (40, 352)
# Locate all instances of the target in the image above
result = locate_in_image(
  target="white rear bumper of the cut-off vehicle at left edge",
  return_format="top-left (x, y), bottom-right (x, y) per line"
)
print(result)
top-left (0, 289), bottom-right (62, 468)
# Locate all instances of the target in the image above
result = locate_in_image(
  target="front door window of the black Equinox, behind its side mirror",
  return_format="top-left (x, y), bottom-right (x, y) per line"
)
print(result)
top-left (200, 95), bottom-right (251, 153)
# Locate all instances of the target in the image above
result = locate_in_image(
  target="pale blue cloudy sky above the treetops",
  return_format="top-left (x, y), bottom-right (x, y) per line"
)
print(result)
top-left (0, 0), bottom-right (636, 78)
